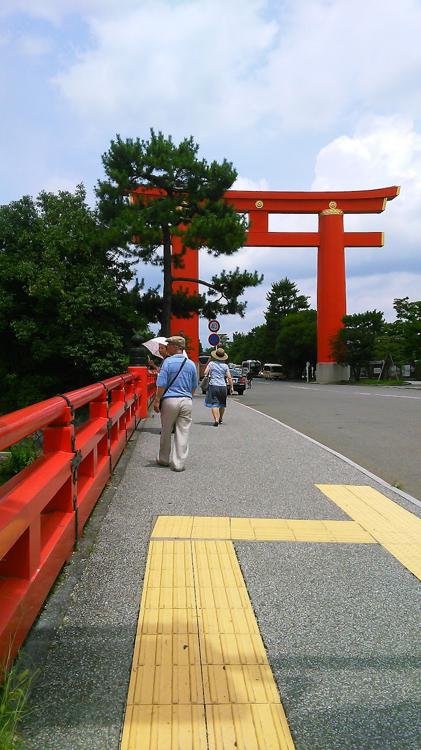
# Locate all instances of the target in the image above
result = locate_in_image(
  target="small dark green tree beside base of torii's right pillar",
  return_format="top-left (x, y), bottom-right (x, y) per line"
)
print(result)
top-left (332, 310), bottom-right (385, 381)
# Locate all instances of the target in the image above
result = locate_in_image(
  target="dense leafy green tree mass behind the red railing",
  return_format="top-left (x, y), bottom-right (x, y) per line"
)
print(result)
top-left (0, 186), bottom-right (149, 411)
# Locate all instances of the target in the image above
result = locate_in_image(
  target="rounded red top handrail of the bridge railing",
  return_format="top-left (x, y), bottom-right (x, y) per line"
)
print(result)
top-left (0, 373), bottom-right (136, 451)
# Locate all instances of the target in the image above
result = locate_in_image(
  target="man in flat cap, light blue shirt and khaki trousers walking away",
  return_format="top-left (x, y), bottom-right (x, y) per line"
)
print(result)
top-left (153, 336), bottom-right (197, 471)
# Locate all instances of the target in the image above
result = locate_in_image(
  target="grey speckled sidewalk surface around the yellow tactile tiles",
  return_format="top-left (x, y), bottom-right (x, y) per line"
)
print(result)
top-left (20, 397), bottom-right (421, 750)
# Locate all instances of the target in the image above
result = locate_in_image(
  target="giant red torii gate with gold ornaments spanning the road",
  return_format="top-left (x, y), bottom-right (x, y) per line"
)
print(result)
top-left (171, 186), bottom-right (399, 383)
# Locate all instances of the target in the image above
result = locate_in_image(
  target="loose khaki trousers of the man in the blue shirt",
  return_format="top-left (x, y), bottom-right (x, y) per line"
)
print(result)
top-left (158, 397), bottom-right (192, 471)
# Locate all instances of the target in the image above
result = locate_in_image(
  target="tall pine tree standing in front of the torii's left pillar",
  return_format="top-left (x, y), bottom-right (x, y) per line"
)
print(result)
top-left (97, 130), bottom-right (263, 335)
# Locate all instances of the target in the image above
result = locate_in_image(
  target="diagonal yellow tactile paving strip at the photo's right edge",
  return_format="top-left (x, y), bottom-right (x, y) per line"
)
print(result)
top-left (316, 484), bottom-right (421, 578)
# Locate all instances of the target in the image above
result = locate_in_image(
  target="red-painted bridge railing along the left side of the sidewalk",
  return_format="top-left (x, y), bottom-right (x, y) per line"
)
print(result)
top-left (0, 367), bottom-right (156, 662)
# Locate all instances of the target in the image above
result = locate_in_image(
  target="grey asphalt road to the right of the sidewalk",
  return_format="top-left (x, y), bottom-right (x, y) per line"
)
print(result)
top-left (243, 380), bottom-right (421, 500)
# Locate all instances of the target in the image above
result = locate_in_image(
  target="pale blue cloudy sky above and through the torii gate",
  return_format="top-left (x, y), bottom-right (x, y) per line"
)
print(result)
top-left (0, 0), bottom-right (421, 340)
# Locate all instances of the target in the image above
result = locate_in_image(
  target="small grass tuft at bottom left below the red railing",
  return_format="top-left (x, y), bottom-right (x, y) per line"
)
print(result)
top-left (0, 663), bottom-right (36, 750)
